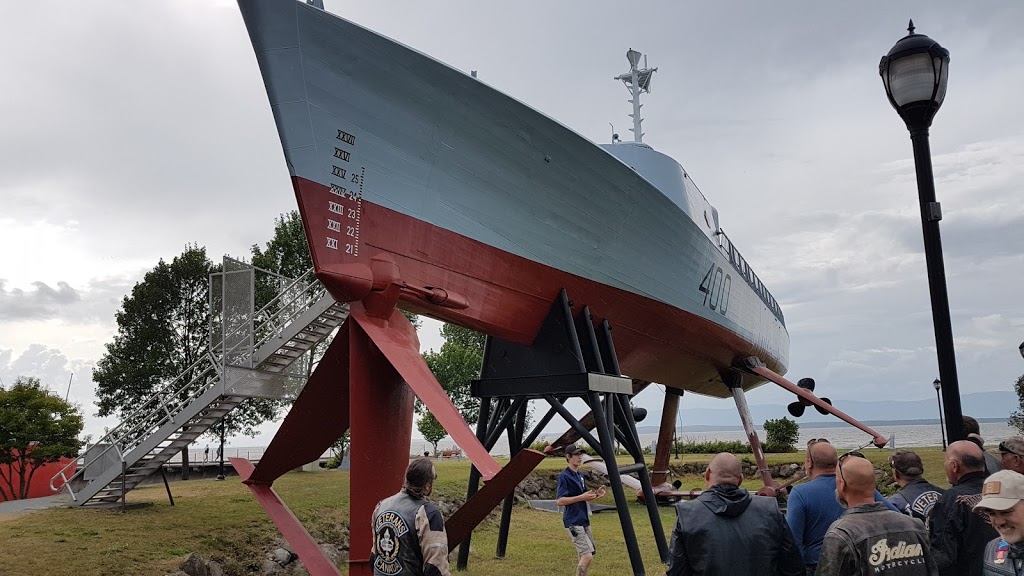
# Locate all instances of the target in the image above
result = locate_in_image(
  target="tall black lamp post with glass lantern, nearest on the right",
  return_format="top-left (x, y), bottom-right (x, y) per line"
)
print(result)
top-left (879, 20), bottom-right (964, 442)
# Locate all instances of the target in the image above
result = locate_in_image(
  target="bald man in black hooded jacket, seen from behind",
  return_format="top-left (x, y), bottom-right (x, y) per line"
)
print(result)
top-left (667, 452), bottom-right (804, 576)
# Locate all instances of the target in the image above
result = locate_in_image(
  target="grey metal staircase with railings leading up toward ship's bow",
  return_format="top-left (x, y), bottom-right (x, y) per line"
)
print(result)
top-left (50, 271), bottom-right (348, 507)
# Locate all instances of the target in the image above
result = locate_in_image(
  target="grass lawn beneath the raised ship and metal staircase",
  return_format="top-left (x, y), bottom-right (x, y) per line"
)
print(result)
top-left (0, 448), bottom-right (948, 576)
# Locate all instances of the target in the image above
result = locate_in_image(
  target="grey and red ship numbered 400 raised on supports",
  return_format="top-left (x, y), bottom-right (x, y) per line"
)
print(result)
top-left (232, 0), bottom-right (884, 574)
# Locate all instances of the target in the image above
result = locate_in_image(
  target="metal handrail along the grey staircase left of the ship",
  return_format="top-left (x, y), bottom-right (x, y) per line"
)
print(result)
top-left (49, 269), bottom-right (326, 499)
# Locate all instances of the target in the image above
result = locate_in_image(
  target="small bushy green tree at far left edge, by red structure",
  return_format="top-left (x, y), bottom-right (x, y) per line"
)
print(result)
top-left (0, 376), bottom-right (84, 500)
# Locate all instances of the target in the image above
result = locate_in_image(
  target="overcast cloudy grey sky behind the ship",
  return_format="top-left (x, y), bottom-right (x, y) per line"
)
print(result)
top-left (0, 0), bottom-right (1024, 445)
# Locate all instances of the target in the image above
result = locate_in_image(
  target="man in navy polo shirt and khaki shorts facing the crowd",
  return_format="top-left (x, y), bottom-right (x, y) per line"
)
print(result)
top-left (555, 446), bottom-right (604, 576)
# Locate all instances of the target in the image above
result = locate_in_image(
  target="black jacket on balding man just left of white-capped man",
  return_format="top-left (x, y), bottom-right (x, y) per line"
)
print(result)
top-left (928, 472), bottom-right (998, 576)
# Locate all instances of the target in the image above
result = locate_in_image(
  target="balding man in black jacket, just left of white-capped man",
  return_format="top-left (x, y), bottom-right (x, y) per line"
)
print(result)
top-left (928, 440), bottom-right (996, 576)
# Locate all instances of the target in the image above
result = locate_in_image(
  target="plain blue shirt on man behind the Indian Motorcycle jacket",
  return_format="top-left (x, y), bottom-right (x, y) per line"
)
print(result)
top-left (785, 474), bottom-right (899, 565)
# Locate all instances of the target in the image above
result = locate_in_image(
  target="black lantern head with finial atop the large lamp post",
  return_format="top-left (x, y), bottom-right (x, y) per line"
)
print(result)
top-left (879, 20), bottom-right (949, 130)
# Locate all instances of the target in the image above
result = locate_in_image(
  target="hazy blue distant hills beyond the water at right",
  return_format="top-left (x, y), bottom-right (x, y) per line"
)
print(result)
top-left (638, 392), bottom-right (1020, 433)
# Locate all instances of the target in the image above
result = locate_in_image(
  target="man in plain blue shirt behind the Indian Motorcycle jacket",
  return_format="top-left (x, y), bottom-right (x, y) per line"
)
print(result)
top-left (785, 439), bottom-right (899, 575)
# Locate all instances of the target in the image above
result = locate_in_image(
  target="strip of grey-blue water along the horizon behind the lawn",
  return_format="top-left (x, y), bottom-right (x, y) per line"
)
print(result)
top-left (171, 422), bottom-right (1020, 462)
